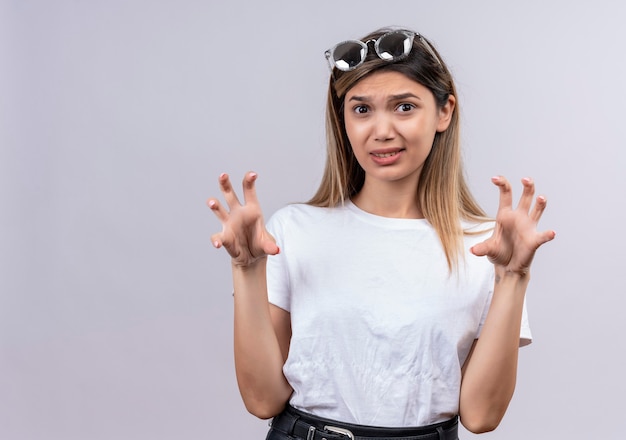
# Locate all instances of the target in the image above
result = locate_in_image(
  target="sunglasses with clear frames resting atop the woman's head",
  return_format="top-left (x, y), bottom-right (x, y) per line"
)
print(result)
top-left (324, 30), bottom-right (441, 72)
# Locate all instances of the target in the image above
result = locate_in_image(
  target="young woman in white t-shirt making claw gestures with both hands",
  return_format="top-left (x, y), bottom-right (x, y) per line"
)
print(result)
top-left (207, 29), bottom-right (555, 440)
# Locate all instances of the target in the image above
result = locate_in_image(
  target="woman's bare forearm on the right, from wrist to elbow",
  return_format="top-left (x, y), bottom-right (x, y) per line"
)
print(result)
top-left (459, 268), bottom-right (529, 432)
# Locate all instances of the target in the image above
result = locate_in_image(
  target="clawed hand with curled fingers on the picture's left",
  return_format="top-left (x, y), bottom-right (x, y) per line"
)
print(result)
top-left (207, 173), bottom-right (279, 267)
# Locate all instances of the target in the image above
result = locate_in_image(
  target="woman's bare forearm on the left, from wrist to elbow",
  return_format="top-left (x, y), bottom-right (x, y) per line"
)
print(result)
top-left (233, 259), bottom-right (292, 418)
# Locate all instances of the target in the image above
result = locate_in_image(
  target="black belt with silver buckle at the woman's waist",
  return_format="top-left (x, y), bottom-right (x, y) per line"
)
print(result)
top-left (272, 405), bottom-right (459, 440)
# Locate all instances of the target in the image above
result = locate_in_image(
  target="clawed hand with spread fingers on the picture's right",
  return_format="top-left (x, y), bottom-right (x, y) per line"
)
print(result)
top-left (471, 176), bottom-right (556, 275)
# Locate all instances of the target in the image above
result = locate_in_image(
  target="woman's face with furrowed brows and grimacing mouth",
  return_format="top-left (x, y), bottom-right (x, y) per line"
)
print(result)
top-left (344, 71), bottom-right (454, 188)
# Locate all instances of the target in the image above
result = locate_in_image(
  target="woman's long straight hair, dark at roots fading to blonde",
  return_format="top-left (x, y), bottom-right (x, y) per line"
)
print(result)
top-left (307, 28), bottom-right (488, 270)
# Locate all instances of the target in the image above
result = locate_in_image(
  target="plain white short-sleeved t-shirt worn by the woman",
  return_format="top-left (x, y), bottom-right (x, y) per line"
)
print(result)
top-left (267, 202), bottom-right (531, 427)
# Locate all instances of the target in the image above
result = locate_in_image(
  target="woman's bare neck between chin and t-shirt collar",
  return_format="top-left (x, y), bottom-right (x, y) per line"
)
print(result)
top-left (352, 179), bottom-right (424, 218)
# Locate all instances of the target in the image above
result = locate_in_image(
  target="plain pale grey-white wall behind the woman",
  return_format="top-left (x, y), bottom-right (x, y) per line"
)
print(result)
top-left (0, 0), bottom-right (626, 440)
